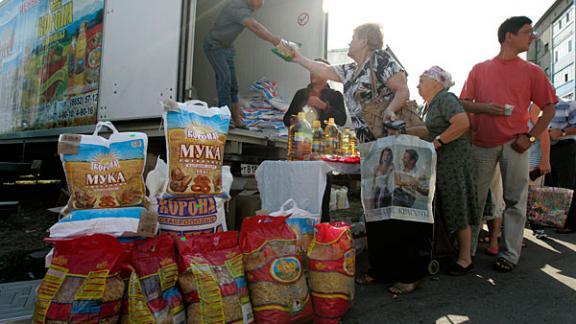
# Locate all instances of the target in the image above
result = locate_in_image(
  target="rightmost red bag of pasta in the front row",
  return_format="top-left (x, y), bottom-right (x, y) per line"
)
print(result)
top-left (308, 222), bottom-right (356, 324)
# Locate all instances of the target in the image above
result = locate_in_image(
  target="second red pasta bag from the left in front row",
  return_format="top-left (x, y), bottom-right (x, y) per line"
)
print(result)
top-left (122, 235), bottom-right (185, 324)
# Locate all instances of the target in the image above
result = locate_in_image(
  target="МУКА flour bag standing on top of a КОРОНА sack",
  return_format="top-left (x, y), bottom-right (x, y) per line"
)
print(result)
top-left (163, 100), bottom-right (230, 196)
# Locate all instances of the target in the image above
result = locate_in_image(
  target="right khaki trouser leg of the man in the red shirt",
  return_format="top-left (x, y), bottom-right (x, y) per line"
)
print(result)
top-left (499, 144), bottom-right (529, 264)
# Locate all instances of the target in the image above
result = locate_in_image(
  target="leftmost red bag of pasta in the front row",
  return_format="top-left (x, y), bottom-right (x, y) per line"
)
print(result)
top-left (33, 234), bottom-right (125, 323)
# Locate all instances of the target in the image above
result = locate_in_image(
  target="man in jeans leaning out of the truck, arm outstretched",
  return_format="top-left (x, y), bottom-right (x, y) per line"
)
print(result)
top-left (204, 0), bottom-right (280, 128)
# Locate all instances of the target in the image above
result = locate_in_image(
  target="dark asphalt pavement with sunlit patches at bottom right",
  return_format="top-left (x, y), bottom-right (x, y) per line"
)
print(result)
top-left (344, 230), bottom-right (576, 324)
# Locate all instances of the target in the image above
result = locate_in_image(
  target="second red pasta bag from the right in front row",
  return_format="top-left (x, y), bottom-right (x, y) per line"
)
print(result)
top-left (240, 216), bottom-right (314, 323)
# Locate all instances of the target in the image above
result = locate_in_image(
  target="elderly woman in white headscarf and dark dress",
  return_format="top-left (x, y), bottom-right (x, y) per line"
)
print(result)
top-left (418, 66), bottom-right (480, 275)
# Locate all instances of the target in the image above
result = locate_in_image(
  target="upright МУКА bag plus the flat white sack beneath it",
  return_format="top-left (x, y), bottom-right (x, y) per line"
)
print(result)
top-left (49, 122), bottom-right (157, 238)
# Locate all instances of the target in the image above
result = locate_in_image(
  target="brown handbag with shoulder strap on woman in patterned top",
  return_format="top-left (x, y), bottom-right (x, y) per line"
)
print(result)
top-left (361, 55), bottom-right (428, 138)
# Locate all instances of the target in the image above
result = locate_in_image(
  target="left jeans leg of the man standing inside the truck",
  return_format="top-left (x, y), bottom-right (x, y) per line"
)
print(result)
top-left (204, 40), bottom-right (232, 107)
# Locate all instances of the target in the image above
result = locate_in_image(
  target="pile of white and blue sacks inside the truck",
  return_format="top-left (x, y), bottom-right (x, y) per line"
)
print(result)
top-left (241, 79), bottom-right (289, 137)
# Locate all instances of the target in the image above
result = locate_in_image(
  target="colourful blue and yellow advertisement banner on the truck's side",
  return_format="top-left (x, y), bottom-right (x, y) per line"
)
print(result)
top-left (0, 0), bottom-right (104, 134)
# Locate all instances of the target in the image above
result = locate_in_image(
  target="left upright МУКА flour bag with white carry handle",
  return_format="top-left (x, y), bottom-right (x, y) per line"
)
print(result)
top-left (58, 122), bottom-right (148, 209)
